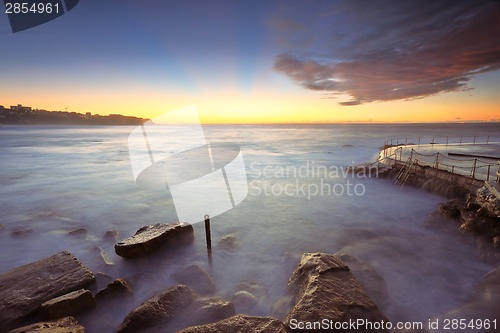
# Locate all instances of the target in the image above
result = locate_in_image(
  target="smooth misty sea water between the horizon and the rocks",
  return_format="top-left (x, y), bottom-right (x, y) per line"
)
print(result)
top-left (0, 124), bottom-right (500, 332)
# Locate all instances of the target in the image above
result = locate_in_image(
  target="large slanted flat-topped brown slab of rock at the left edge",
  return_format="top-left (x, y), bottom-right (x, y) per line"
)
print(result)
top-left (0, 251), bottom-right (95, 332)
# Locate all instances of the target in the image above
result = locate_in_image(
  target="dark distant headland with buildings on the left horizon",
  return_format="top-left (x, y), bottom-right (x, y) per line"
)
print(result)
top-left (0, 104), bottom-right (148, 125)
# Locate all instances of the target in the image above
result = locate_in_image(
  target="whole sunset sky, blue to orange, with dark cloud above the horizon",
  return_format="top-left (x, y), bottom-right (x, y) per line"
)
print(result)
top-left (0, 0), bottom-right (500, 123)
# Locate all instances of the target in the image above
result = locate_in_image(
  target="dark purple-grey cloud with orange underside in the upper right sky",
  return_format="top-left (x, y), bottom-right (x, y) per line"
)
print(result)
top-left (274, 0), bottom-right (500, 105)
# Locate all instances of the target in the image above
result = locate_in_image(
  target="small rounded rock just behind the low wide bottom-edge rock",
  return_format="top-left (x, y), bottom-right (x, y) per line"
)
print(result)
top-left (186, 297), bottom-right (235, 325)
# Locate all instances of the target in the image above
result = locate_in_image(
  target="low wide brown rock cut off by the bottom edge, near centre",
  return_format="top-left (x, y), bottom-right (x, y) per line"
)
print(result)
top-left (178, 314), bottom-right (286, 333)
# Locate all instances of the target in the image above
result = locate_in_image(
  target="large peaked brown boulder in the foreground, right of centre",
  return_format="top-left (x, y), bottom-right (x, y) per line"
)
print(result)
top-left (285, 253), bottom-right (387, 332)
